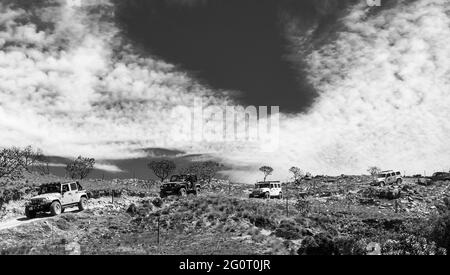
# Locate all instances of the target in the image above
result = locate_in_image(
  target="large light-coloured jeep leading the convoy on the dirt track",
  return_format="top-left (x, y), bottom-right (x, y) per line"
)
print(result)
top-left (25, 181), bottom-right (88, 219)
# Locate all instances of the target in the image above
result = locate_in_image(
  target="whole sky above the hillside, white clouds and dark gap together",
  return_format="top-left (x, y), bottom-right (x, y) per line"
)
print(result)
top-left (0, 0), bottom-right (450, 181)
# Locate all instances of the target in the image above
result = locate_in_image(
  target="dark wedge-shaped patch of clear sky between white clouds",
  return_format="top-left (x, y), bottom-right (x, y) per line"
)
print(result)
top-left (112, 0), bottom-right (362, 112)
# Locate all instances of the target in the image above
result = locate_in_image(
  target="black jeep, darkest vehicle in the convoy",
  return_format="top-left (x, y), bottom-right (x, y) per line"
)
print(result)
top-left (159, 175), bottom-right (200, 198)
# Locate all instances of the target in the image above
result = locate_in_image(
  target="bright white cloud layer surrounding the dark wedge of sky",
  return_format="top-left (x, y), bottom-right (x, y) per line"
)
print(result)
top-left (0, 0), bottom-right (450, 181)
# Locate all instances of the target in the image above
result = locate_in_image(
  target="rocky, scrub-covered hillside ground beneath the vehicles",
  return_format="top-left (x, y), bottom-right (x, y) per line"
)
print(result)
top-left (0, 176), bottom-right (450, 255)
